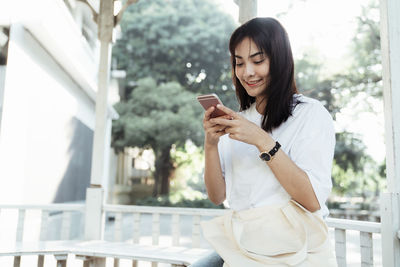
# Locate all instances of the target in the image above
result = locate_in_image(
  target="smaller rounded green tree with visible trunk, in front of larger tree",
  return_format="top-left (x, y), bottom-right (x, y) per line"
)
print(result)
top-left (112, 78), bottom-right (203, 196)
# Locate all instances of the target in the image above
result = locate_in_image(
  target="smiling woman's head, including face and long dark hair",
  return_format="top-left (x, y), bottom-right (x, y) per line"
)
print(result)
top-left (229, 18), bottom-right (298, 131)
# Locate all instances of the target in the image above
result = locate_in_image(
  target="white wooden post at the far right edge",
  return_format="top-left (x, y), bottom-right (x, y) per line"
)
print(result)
top-left (380, 0), bottom-right (400, 267)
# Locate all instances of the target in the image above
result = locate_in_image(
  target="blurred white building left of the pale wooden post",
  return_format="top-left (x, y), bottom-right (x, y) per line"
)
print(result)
top-left (0, 0), bottom-right (116, 204)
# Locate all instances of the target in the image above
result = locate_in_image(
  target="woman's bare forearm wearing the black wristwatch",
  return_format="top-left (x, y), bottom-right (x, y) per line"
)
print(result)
top-left (256, 133), bottom-right (320, 212)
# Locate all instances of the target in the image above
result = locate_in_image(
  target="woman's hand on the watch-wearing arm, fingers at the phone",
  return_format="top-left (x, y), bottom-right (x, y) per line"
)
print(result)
top-left (210, 105), bottom-right (275, 149)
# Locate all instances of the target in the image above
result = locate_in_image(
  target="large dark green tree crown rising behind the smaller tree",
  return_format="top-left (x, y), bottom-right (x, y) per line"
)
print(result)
top-left (113, 0), bottom-right (237, 107)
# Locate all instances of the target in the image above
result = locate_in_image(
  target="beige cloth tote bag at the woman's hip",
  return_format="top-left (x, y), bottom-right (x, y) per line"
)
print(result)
top-left (201, 201), bottom-right (337, 267)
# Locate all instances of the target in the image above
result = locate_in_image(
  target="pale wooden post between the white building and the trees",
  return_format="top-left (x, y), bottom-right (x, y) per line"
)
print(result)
top-left (85, 0), bottom-right (114, 243)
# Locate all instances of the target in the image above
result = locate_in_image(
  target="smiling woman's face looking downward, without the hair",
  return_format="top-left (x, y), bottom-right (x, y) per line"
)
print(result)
top-left (235, 38), bottom-right (269, 102)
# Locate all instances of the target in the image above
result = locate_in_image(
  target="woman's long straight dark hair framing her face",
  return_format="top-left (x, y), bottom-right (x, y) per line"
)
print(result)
top-left (229, 18), bottom-right (298, 132)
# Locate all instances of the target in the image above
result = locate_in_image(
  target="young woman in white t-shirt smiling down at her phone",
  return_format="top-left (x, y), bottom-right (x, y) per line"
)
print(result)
top-left (192, 18), bottom-right (336, 267)
